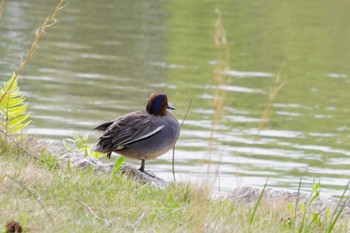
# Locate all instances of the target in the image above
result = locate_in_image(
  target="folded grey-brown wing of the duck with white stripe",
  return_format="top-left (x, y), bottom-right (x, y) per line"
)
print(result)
top-left (97, 111), bottom-right (164, 151)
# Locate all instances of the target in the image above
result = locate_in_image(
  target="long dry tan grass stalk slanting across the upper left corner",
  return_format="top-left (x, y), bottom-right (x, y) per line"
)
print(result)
top-left (0, 0), bottom-right (66, 102)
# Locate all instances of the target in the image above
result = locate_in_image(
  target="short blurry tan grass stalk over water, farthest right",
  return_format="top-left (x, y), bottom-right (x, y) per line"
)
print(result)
top-left (257, 74), bottom-right (284, 135)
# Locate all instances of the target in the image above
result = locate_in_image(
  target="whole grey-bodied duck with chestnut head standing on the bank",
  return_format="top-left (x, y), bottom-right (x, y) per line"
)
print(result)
top-left (93, 93), bottom-right (180, 172)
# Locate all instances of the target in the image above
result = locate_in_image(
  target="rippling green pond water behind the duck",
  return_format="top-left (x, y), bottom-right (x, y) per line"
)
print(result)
top-left (0, 0), bottom-right (350, 195)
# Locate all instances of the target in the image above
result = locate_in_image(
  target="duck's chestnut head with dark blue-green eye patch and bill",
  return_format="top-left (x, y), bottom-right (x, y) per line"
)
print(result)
top-left (146, 92), bottom-right (175, 116)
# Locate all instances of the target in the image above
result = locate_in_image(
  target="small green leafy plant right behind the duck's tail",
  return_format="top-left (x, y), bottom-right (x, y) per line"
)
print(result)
top-left (63, 132), bottom-right (105, 158)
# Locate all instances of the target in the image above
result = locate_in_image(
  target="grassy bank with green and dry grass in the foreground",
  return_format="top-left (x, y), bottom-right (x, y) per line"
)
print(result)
top-left (0, 140), bottom-right (349, 233)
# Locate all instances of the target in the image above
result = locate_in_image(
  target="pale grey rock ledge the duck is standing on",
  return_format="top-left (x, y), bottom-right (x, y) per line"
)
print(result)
top-left (24, 138), bottom-right (167, 188)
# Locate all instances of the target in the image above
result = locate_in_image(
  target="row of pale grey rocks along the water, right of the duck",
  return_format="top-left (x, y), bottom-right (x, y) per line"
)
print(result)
top-left (225, 186), bottom-right (350, 215)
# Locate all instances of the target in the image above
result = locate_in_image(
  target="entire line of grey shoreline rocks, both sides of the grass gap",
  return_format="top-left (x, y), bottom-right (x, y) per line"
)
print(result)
top-left (26, 138), bottom-right (350, 215)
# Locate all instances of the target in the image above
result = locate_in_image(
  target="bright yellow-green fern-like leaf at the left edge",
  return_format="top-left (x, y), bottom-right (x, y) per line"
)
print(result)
top-left (0, 72), bottom-right (31, 134)
